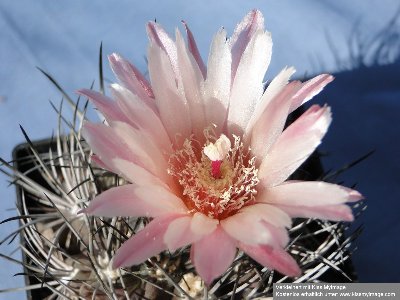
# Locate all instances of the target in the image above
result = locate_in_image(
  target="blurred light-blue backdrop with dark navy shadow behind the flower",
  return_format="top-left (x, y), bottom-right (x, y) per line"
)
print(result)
top-left (0, 0), bottom-right (400, 299)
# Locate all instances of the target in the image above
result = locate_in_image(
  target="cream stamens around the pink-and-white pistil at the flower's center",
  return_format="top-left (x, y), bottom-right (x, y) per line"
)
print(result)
top-left (168, 134), bottom-right (259, 220)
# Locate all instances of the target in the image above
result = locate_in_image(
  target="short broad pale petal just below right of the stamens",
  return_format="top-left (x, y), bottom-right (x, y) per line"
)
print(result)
top-left (221, 204), bottom-right (290, 245)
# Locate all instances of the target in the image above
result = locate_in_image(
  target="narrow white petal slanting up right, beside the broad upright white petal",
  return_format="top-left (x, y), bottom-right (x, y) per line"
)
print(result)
top-left (245, 67), bottom-right (296, 135)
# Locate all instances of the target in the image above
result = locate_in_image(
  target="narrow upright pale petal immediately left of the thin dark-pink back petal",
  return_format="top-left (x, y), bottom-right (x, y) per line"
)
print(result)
top-left (176, 30), bottom-right (206, 143)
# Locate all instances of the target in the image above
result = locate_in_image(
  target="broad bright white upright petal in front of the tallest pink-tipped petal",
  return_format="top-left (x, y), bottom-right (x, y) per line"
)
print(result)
top-left (228, 30), bottom-right (272, 135)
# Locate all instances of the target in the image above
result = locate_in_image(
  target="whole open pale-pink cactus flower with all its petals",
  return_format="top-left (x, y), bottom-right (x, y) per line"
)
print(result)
top-left (79, 10), bottom-right (362, 284)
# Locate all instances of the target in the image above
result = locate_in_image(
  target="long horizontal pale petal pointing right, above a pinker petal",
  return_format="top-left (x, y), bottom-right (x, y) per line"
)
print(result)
top-left (257, 181), bottom-right (363, 206)
